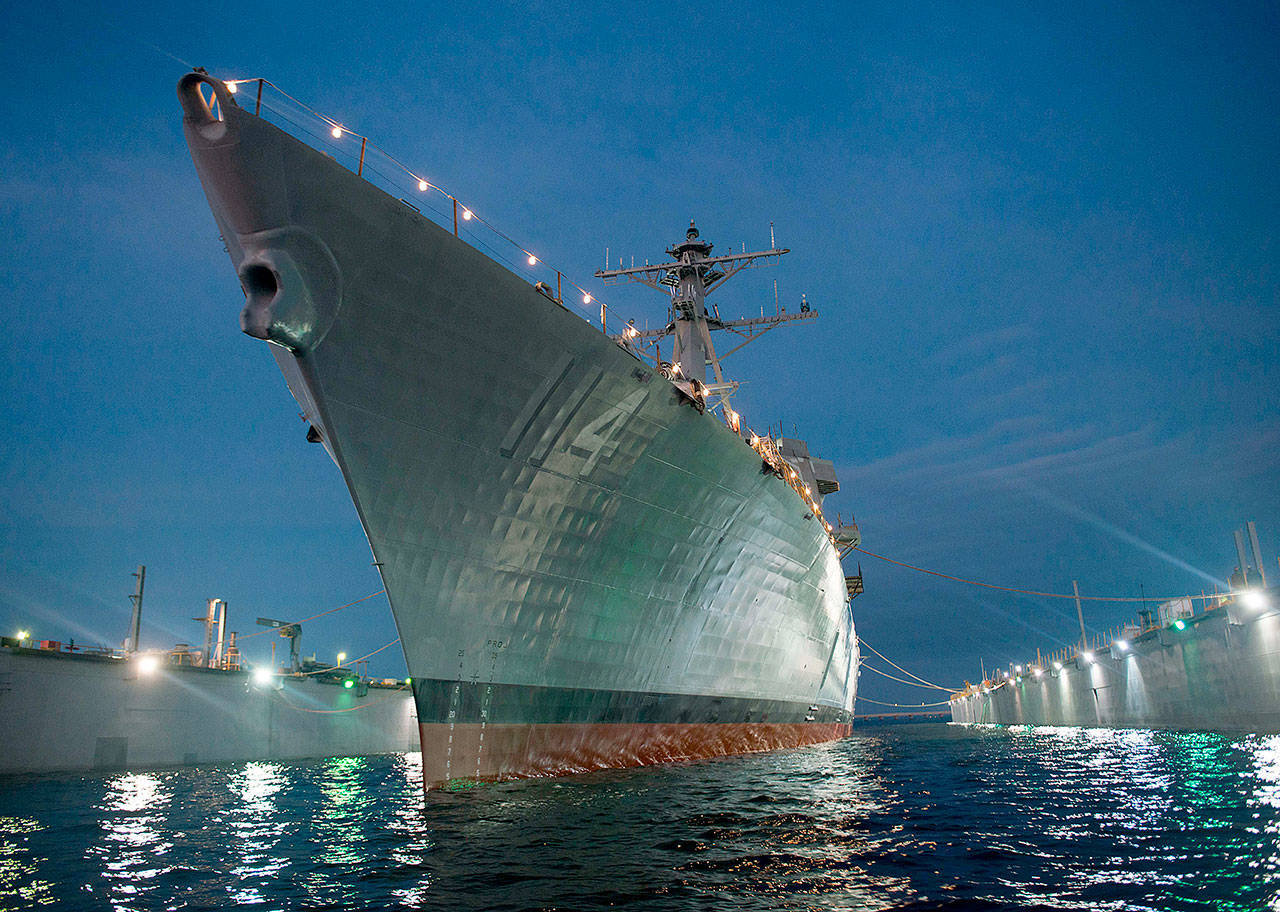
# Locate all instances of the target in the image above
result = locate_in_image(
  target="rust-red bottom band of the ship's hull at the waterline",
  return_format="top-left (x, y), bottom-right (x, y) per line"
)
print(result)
top-left (419, 722), bottom-right (852, 789)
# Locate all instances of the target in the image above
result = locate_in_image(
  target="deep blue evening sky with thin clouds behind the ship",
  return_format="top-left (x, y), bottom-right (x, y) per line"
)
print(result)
top-left (0, 3), bottom-right (1280, 702)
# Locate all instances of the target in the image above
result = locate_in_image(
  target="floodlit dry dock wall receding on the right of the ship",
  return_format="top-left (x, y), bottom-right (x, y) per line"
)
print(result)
top-left (951, 607), bottom-right (1280, 733)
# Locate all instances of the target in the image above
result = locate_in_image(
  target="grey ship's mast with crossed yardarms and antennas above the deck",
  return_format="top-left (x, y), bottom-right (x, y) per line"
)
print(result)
top-left (595, 222), bottom-right (818, 406)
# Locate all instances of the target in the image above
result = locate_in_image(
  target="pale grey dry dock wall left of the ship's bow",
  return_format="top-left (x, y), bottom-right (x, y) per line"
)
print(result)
top-left (0, 648), bottom-right (420, 772)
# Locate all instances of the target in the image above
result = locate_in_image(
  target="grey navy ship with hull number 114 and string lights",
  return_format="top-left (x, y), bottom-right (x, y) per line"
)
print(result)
top-left (178, 70), bottom-right (861, 788)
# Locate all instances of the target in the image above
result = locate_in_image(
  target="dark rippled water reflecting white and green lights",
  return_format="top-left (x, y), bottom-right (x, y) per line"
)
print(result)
top-left (0, 725), bottom-right (1280, 909)
